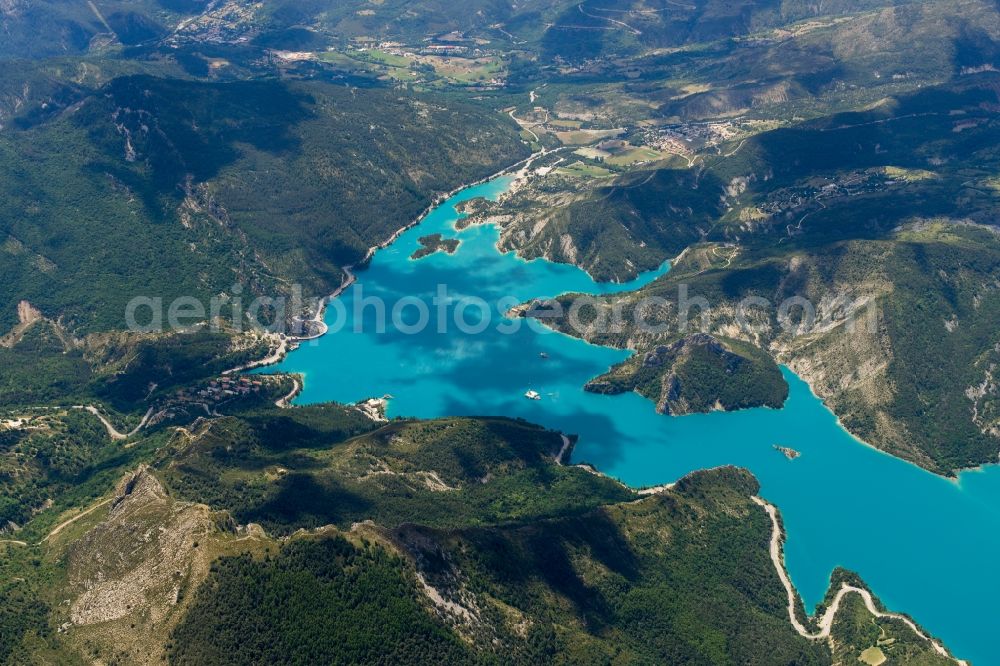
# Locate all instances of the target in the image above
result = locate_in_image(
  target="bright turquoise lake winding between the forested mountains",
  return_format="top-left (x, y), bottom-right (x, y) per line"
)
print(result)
top-left (269, 178), bottom-right (1000, 666)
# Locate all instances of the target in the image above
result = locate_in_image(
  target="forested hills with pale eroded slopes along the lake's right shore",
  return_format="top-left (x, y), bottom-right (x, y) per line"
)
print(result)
top-left (512, 74), bottom-right (1000, 472)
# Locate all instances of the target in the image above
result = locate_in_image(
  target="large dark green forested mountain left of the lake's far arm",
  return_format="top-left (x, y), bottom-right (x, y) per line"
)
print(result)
top-left (0, 76), bottom-right (527, 331)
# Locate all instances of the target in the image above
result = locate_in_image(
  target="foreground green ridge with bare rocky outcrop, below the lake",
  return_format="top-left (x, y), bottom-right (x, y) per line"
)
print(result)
top-left (0, 406), bottom-right (964, 664)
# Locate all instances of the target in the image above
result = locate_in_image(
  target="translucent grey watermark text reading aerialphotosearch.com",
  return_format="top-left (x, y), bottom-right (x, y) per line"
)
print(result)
top-left (125, 283), bottom-right (876, 338)
